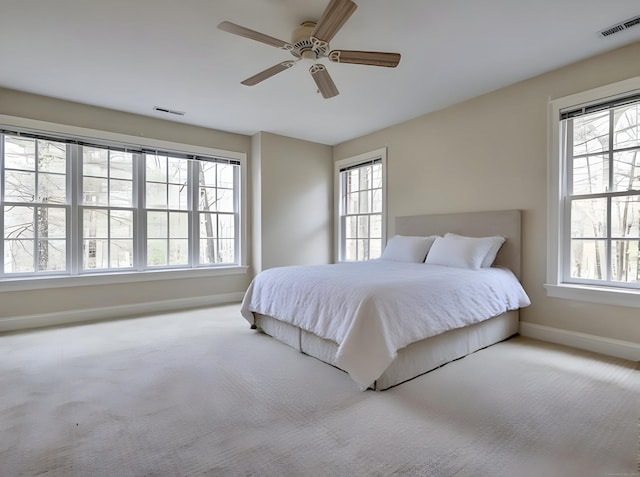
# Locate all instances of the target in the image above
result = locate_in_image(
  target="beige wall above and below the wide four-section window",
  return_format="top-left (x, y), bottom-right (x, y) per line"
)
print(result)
top-left (0, 89), bottom-right (251, 321)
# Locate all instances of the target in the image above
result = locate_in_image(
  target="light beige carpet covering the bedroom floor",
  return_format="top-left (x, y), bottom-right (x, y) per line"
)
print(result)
top-left (0, 305), bottom-right (640, 477)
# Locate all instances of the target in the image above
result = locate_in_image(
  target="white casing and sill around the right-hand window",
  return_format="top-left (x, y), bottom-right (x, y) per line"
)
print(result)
top-left (545, 76), bottom-right (640, 308)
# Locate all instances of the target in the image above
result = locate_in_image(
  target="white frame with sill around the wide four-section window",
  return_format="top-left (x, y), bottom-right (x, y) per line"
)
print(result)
top-left (0, 114), bottom-right (249, 292)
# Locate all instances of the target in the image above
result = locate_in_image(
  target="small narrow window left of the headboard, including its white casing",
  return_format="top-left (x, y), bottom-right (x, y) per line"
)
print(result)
top-left (336, 149), bottom-right (386, 261)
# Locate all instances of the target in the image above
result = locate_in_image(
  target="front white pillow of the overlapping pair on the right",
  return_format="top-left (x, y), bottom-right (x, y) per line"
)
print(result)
top-left (425, 235), bottom-right (492, 270)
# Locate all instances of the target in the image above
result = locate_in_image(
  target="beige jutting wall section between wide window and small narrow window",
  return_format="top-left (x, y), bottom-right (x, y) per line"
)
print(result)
top-left (251, 132), bottom-right (333, 271)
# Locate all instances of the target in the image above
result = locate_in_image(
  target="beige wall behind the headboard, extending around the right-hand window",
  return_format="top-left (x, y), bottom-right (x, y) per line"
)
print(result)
top-left (334, 43), bottom-right (640, 342)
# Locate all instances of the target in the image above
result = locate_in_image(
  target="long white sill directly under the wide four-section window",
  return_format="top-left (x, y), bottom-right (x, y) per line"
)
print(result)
top-left (0, 266), bottom-right (249, 293)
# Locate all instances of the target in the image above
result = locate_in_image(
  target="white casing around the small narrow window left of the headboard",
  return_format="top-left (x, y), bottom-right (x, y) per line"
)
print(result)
top-left (333, 147), bottom-right (387, 262)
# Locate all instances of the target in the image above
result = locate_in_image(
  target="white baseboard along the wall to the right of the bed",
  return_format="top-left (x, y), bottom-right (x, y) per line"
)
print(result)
top-left (520, 321), bottom-right (640, 361)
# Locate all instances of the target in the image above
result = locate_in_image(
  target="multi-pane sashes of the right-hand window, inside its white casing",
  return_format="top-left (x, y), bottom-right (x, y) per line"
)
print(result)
top-left (562, 98), bottom-right (640, 287)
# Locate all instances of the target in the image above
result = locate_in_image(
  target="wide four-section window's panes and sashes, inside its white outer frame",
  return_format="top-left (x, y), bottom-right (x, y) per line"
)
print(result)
top-left (0, 131), bottom-right (240, 278)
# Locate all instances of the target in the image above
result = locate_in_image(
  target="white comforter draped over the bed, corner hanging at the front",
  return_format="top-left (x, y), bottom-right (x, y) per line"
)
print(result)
top-left (242, 260), bottom-right (530, 389)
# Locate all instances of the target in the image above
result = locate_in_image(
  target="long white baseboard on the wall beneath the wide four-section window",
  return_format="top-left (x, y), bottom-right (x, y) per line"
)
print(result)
top-left (0, 292), bottom-right (244, 332)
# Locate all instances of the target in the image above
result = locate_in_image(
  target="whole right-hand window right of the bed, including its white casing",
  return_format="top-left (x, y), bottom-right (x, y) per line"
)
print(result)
top-left (547, 75), bottom-right (640, 306)
